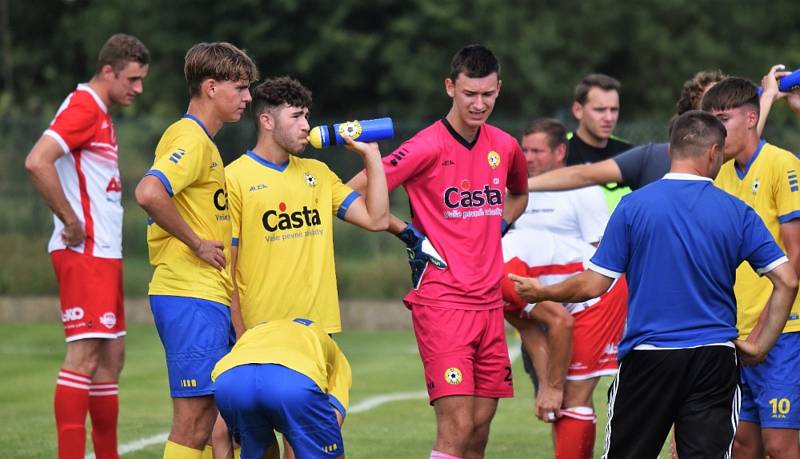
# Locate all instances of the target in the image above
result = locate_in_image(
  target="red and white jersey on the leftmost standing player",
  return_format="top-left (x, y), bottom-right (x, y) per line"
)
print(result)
top-left (44, 84), bottom-right (122, 258)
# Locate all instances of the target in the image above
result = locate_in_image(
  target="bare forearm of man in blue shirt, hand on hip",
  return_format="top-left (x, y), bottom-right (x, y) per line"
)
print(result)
top-left (734, 263), bottom-right (797, 365)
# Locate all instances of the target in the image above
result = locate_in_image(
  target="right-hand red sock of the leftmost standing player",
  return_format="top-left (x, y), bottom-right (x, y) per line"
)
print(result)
top-left (89, 381), bottom-right (119, 459)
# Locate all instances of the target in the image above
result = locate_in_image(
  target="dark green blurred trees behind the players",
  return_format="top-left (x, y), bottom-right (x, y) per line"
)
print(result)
top-left (0, 0), bottom-right (800, 297)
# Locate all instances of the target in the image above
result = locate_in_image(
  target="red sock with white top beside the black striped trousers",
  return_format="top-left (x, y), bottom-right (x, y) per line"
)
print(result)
top-left (553, 406), bottom-right (596, 459)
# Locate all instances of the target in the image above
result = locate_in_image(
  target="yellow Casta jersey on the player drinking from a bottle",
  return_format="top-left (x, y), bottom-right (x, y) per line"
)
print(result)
top-left (225, 151), bottom-right (359, 333)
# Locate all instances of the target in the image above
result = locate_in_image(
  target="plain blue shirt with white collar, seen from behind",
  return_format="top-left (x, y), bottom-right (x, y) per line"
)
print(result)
top-left (589, 173), bottom-right (788, 360)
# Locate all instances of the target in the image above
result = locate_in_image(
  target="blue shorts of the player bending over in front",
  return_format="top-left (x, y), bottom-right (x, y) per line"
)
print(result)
top-left (214, 364), bottom-right (344, 459)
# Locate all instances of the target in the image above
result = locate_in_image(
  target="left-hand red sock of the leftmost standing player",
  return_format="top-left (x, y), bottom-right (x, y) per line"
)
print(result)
top-left (53, 368), bottom-right (92, 459)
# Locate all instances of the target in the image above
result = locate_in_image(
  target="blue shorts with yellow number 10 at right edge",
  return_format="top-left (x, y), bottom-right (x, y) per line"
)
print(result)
top-left (739, 332), bottom-right (800, 429)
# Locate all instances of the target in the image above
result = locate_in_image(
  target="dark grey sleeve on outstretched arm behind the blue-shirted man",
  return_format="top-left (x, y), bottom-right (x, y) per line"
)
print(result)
top-left (613, 143), bottom-right (670, 190)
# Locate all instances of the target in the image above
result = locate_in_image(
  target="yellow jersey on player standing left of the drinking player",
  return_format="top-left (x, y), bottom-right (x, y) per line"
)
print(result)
top-left (147, 115), bottom-right (232, 305)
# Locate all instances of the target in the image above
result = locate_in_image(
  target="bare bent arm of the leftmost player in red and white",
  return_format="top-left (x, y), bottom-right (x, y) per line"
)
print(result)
top-left (25, 135), bottom-right (86, 247)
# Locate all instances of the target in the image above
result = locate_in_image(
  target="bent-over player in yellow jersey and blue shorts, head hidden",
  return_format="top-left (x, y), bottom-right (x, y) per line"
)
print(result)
top-left (211, 319), bottom-right (352, 459)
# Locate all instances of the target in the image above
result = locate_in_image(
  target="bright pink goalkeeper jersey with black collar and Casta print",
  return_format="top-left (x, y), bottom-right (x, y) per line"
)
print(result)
top-left (383, 119), bottom-right (528, 309)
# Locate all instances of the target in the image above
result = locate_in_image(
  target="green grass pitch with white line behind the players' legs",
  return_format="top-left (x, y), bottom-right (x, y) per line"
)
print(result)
top-left (0, 323), bottom-right (636, 459)
